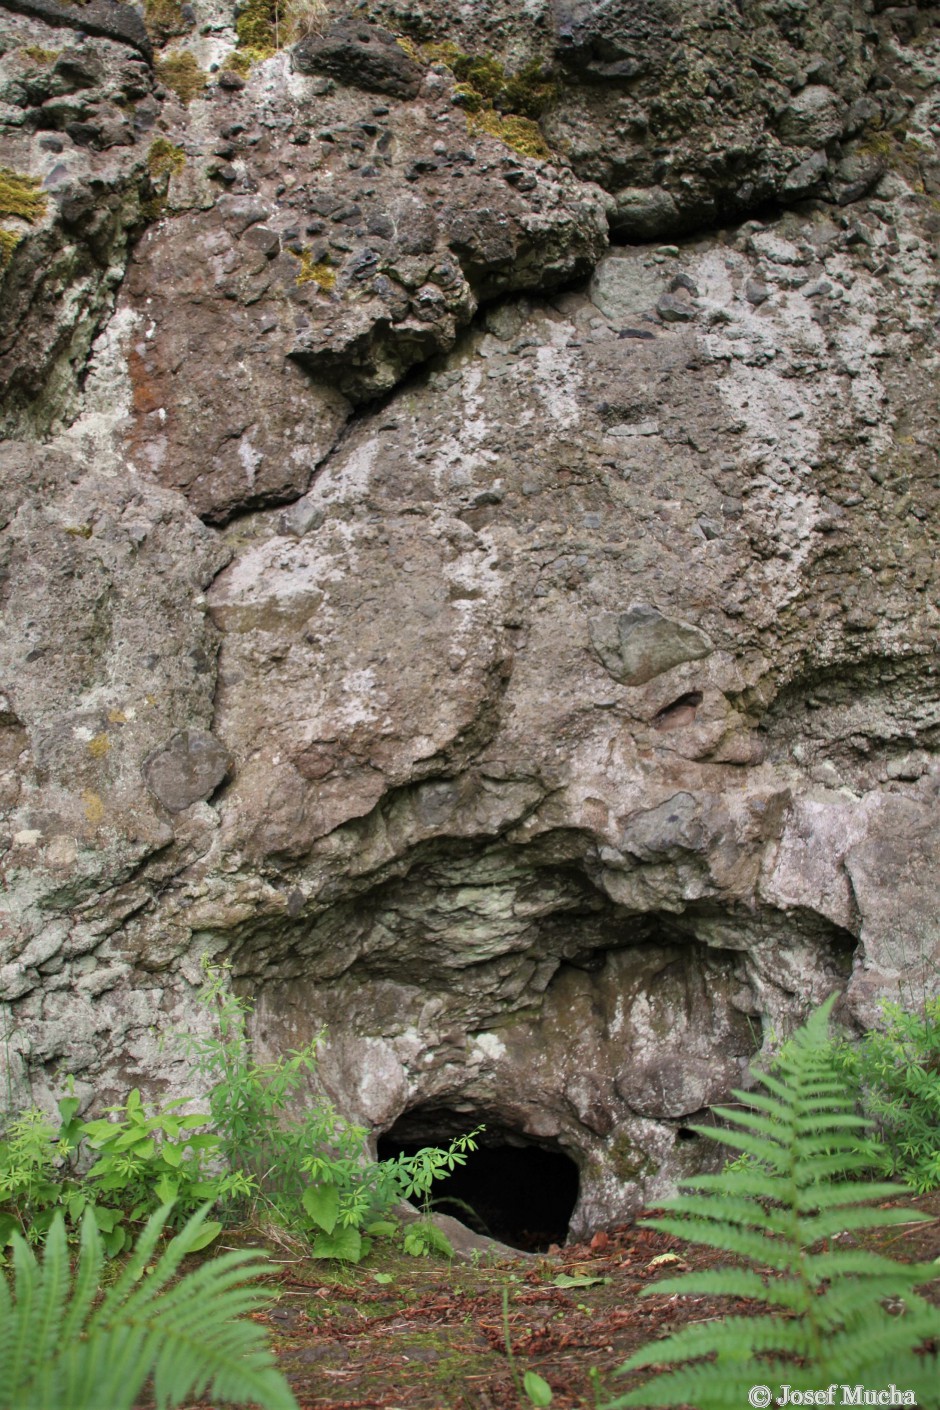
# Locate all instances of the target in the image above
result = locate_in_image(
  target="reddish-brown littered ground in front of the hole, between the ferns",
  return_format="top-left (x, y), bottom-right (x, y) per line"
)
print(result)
top-left (194, 1193), bottom-right (940, 1410)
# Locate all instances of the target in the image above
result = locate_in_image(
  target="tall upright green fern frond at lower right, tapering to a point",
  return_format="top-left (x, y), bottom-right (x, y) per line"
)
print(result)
top-left (606, 1000), bottom-right (940, 1410)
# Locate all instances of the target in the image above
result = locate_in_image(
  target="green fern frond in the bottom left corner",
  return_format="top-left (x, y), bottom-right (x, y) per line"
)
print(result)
top-left (0, 1206), bottom-right (297, 1410)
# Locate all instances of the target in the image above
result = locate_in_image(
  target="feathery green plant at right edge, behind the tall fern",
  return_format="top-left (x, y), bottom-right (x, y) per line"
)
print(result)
top-left (837, 998), bottom-right (940, 1194)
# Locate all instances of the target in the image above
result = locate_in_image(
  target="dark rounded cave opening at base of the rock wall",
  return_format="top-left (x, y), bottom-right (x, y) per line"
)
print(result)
top-left (378, 1108), bottom-right (579, 1253)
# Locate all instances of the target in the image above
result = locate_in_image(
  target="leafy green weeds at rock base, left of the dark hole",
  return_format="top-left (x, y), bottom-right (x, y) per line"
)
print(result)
top-left (0, 967), bottom-right (478, 1263)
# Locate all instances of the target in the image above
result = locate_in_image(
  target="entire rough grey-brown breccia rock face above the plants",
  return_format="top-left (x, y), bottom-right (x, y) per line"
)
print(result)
top-left (0, 0), bottom-right (940, 1232)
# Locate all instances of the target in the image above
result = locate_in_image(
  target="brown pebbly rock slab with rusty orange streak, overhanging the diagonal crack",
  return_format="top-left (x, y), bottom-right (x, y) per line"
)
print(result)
top-left (120, 47), bottom-right (606, 522)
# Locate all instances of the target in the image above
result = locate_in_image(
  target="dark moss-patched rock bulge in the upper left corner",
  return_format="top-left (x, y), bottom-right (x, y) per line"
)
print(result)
top-left (0, 0), bottom-right (152, 434)
